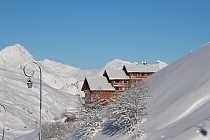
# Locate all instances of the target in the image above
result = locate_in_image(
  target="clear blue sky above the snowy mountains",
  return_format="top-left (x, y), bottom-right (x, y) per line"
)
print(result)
top-left (0, 0), bottom-right (210, 69)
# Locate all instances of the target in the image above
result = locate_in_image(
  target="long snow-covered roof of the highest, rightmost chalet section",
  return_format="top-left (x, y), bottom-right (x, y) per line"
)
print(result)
top-left (124, 64), bottom-right (160, 73)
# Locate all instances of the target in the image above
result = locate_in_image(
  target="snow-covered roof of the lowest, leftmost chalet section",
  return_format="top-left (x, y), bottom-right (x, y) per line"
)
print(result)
top-left (86, 76), bottom-right (115, 91)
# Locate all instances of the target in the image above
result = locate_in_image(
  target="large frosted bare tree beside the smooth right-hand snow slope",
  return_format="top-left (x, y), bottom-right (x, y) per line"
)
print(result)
top-left (107, 82), bottom-right (150, 137)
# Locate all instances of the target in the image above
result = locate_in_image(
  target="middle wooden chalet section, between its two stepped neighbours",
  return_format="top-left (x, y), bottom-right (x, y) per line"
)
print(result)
top-left (103, 70), bottom-right (130, 92)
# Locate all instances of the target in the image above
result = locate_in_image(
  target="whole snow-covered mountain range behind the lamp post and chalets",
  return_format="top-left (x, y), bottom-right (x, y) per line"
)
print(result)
top-left (0, 44), bottom-right (166, 139)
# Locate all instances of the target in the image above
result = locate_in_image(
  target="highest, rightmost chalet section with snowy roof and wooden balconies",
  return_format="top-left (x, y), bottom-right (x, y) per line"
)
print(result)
top-left (123, 62), bottom-right (160, 85)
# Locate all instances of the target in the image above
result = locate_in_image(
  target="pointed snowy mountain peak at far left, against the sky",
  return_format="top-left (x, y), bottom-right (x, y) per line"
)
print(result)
top-left (0, 44), bottom-right (34, 67)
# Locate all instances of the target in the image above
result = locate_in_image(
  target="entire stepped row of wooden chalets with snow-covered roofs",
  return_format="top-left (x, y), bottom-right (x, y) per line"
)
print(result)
top-left (82, 61), bottom-right (167, 103)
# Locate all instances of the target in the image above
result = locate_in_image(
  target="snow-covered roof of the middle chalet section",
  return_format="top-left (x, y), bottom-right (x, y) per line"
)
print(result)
top-left (105, 70), bottom-right (129, 80)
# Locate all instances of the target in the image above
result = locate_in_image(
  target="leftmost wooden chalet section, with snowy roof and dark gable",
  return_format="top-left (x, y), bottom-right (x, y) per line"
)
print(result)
top-left (82, 76), bottom-right (115, 103)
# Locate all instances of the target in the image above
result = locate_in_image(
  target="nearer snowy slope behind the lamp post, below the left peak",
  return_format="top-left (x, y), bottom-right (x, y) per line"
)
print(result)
top-left (0, 65), bottom-right (78, 139)
